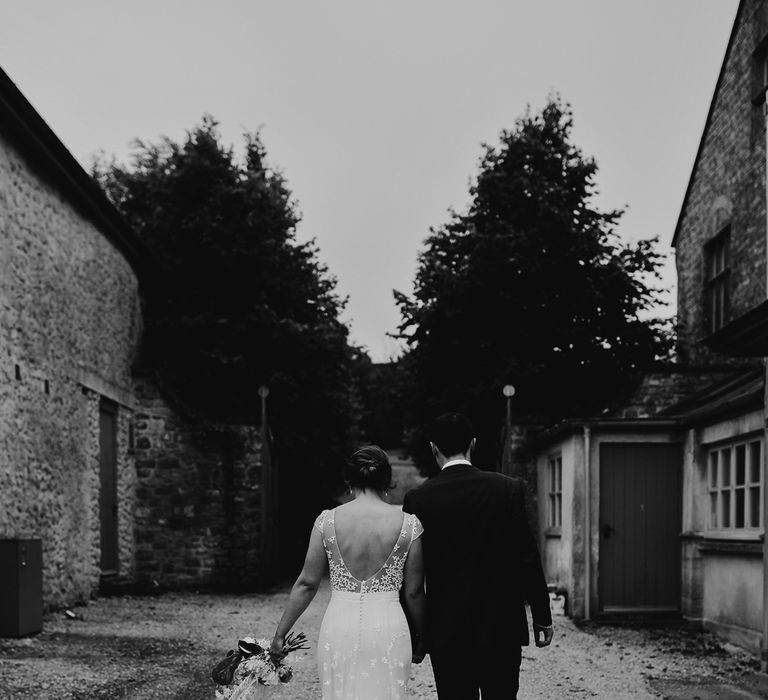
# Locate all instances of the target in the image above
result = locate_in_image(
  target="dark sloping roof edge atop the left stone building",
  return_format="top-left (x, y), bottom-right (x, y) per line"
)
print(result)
top-left (0, 69), bottom-right (152, 284)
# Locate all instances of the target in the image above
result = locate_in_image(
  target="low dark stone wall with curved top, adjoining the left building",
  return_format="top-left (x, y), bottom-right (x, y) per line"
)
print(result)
top-left (133, 378), bottom-right (272, 589)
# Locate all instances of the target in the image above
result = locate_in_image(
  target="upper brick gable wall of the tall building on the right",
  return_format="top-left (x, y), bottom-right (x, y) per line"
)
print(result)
top-left (676, 0), bottom-right (766, 363)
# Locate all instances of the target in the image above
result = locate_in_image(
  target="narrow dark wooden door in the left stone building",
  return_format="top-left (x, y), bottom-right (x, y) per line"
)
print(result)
top-left (99, 400), bottom-right (118, 574)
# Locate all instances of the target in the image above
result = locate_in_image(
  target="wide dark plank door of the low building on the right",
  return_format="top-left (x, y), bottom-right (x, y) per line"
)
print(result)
top-left (598, 444), bottom-right (683, 613)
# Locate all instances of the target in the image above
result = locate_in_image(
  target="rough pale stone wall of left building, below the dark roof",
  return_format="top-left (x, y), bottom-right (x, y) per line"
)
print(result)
top-left (0, 133), bottom-right (141, 607)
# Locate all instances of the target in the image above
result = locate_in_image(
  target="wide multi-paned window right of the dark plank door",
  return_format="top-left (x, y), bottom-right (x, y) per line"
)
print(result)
top-left (707, 439), bottom-right (763, 530)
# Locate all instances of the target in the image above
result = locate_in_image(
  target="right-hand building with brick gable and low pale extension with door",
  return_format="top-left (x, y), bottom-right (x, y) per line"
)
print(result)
top-left (534, 0), bottom-right (768, 664)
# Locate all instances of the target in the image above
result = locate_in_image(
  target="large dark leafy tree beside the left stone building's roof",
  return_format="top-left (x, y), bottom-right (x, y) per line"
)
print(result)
top-left (94, 117), bottom-right (360, 561)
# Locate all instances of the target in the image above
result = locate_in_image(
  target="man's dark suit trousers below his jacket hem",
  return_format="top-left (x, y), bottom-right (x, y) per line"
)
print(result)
top-left (430, 646), bottom-right (522, 700)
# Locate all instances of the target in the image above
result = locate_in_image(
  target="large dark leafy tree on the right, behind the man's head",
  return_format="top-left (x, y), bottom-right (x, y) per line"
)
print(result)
top-left (395, 98), bottom-right (668, 474)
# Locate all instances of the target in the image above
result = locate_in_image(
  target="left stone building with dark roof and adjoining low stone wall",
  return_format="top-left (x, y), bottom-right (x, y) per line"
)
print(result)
top-left (0, 71), bottom-right (273, 608)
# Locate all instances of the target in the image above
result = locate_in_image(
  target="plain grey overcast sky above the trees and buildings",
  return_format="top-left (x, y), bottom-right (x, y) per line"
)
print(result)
top-left (0, 0), bottom-right (738, 361)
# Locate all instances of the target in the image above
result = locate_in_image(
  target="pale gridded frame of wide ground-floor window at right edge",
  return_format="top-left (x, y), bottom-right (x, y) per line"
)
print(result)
top-left (704, 433), bottom-right (765, 538)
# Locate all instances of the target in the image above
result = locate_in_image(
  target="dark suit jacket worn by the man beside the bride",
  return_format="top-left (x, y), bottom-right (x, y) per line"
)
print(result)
top-left (403, 464), bottom-right (552, 653)
